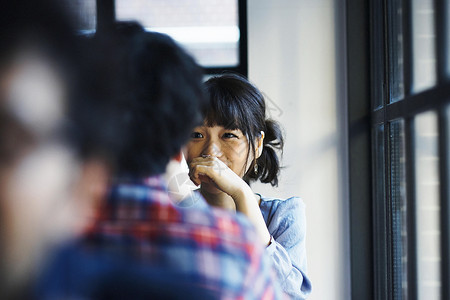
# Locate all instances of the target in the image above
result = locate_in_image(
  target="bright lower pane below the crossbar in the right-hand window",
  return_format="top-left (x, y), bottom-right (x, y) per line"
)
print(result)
top-left (414, 112), bottom-right (441, 299)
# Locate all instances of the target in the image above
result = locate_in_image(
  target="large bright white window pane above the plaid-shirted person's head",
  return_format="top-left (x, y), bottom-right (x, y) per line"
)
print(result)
top-left (116, 0), bottom-right (240, 67)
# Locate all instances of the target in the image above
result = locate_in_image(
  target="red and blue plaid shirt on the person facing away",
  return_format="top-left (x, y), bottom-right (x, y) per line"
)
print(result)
top-left (83, 177), bottom-right (282, 300)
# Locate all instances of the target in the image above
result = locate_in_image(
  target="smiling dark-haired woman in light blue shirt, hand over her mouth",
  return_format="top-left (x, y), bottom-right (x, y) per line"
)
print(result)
top-left (185, 74), bottom-right (311, 299)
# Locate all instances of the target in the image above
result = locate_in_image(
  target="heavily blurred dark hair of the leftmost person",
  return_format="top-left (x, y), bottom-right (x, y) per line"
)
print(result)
top-left (0, 0), bottom-right (121, 165)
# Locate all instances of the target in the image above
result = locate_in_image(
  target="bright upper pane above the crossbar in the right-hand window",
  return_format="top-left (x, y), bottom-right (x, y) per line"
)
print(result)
top-left (412, 0), bottom-right (436, 92)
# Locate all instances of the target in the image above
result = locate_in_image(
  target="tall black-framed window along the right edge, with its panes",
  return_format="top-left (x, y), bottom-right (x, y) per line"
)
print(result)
top-left (347, 0), bottom-right (450, 300)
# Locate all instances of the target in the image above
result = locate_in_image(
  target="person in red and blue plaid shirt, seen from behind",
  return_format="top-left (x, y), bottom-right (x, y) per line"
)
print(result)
top-left (77, 22), bottom-right (283, 299)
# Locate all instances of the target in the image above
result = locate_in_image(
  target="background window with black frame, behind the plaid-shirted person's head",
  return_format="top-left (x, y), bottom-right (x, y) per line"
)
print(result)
top-left (76, 0), bottom-right (248, 76)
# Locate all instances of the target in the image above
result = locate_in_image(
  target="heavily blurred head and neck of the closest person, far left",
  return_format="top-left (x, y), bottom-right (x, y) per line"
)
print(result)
top-left (0, 0), bottom-right (111, 296)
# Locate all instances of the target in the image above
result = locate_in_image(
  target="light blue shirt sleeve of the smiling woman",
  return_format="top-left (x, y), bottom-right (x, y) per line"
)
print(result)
top-left (266, 197), bottom-right (311, 299)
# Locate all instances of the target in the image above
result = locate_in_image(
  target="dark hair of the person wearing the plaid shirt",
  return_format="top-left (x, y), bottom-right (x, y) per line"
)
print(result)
top-left (95, 22), bottom-right (206, 177)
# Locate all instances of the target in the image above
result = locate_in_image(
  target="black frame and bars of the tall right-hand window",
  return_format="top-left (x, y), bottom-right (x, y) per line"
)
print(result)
top-left (346, 0), bottom-right (450, 300)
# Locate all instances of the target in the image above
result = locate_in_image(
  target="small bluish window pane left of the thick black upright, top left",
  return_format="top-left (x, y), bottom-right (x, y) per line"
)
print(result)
top-left (63, 0), bottom-right (97, 33)
